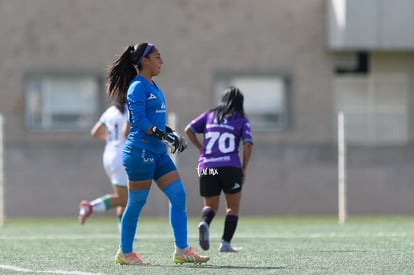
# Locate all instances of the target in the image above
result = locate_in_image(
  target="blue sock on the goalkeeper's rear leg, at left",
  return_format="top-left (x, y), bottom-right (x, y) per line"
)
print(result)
top-left (120, 189), bottom-right (150, 254)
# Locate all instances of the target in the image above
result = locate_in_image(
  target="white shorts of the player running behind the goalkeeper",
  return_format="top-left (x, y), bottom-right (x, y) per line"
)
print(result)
top-left (103, 150), bottom-right (128, 187)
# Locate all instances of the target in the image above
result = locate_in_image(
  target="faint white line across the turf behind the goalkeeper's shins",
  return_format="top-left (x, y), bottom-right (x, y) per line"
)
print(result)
top-left (0, 232), bottom-right (414, 241)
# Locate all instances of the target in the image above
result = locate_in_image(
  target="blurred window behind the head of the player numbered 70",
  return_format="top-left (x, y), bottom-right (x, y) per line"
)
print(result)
top-left (214, 73), bottom-right (289, 131)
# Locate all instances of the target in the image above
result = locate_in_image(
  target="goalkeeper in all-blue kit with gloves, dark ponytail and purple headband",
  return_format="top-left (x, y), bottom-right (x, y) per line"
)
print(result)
top-left (103, 43), bottom-right (209, 265)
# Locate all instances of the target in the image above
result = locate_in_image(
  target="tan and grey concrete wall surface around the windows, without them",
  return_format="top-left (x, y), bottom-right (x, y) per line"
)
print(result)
top-left (0, 0), bottom-right (414, 220)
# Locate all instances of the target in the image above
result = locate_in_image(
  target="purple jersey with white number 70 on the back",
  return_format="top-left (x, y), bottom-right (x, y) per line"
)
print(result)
top-left (187, 111), bottom-right (253, 170)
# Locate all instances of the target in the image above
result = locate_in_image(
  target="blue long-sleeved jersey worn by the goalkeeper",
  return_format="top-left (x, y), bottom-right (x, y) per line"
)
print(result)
top-left (125, 75), bottom-right (167, 153)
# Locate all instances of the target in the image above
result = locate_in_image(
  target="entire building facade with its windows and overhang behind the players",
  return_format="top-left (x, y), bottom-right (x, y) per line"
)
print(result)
top-left (0, 0), bottom-right (414, 217)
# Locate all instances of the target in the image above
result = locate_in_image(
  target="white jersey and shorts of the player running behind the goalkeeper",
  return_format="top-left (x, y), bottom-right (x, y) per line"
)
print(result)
top-left (99, 106), bottom-right (128, 187)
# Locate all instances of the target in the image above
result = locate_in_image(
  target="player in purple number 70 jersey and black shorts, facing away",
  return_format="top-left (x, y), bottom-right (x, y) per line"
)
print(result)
top-left (185, 87), bottom-right (253, 252)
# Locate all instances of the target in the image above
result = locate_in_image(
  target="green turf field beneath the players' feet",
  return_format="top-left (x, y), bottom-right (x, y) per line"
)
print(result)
top-left (0, 216), bottom-right (414, 275)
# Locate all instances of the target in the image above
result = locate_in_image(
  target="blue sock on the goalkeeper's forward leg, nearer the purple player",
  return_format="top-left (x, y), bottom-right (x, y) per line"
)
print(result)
top-left (163, 179), bottom-right (188, 249)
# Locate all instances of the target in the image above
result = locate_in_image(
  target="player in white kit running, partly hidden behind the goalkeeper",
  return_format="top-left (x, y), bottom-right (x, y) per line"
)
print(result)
top-left (79, 102), bottom-right (129, 232)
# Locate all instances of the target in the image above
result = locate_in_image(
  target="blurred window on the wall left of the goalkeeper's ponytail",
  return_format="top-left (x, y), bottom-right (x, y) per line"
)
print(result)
top-left (24, 73), bottom-right (101, 130)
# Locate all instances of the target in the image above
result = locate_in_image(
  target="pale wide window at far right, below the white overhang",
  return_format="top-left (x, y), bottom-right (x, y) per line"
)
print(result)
top-left (335, 74), bottom-right (409, 145)
